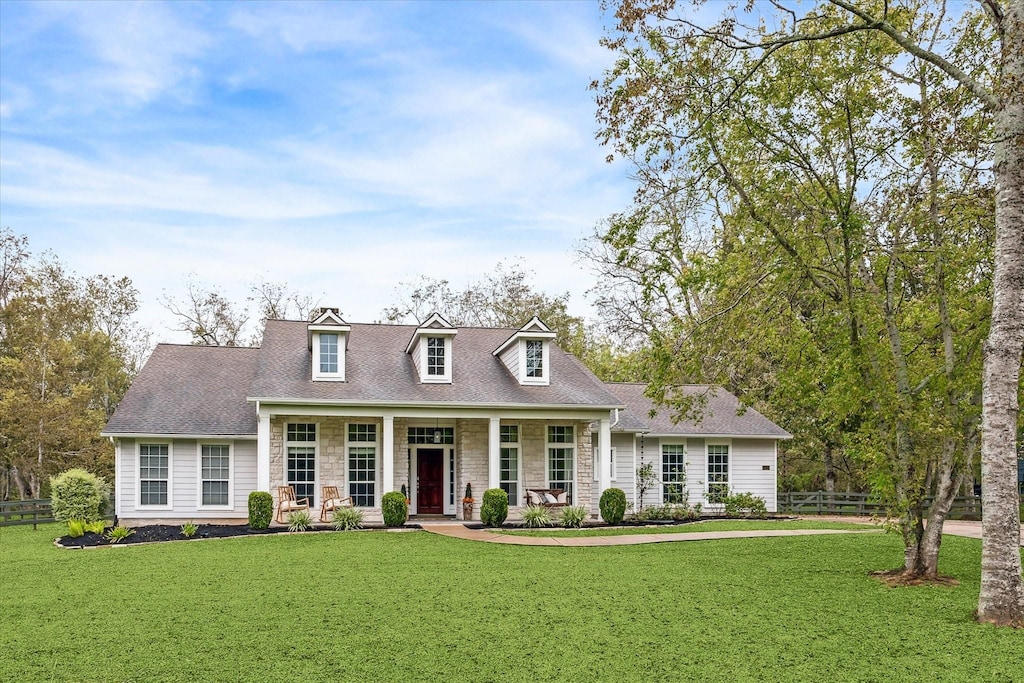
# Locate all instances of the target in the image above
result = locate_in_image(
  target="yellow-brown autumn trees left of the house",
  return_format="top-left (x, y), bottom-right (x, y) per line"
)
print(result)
top-left (0, 229), bottom-right (146, 500)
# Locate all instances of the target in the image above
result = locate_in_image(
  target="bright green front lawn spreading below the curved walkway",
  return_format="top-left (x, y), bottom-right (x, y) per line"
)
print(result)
top-left (0, 526), bottom-right (1024, 682)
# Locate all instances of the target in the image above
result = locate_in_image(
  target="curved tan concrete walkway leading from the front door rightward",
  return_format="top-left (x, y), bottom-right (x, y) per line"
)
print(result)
top-left (422, 522), bottom-right (880, 548)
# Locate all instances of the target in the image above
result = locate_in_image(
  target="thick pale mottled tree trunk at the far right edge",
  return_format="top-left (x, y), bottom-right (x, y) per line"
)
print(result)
top-left (978, 0), bottom-right (1024, 626)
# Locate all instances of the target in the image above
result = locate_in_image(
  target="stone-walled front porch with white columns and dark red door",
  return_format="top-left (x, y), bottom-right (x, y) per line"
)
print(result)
top-left (257, 411), bottom-right (610, 522)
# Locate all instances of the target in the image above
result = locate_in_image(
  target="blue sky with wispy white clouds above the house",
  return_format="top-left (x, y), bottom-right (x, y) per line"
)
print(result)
top-left (0, 0), bottom-right (632, 341)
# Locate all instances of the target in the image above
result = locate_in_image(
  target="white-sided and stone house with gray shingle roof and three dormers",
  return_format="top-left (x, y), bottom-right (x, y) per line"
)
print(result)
top-left (102, 308), bottom-right (787, 523)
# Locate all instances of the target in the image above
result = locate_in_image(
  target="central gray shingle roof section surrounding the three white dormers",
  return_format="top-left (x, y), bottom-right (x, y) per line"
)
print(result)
top-left (249, 321), bottom-right (622, 408)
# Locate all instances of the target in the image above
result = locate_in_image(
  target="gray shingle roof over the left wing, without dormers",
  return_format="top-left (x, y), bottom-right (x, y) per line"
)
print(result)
top-left (103, 344), bottom-right (259, 435)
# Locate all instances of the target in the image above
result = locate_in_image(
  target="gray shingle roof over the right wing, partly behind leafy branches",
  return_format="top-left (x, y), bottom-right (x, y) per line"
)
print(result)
top-left (605, 382), bottom-right (791, 438)
